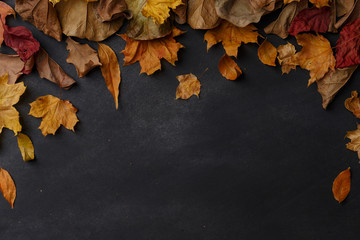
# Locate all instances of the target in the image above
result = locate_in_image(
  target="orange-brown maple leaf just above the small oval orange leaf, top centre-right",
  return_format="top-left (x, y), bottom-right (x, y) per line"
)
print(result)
top-left (204, 21), bottom-right (259, 57)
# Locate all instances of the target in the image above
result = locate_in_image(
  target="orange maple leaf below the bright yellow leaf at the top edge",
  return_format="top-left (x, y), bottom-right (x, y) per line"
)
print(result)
top-left (120, 28), bottom-right (184, 75)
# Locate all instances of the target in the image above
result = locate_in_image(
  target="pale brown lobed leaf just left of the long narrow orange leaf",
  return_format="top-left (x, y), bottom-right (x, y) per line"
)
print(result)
top-left (66, 37), bottom-right (101, 78)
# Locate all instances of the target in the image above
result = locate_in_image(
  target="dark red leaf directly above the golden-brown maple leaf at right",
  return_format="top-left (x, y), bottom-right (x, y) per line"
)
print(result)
top-left (289, 7), bottom-right (331, 36)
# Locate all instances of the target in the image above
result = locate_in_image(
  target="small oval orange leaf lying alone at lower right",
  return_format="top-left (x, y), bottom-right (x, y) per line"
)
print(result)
top-left (332, 167), bottom-right (351, 203)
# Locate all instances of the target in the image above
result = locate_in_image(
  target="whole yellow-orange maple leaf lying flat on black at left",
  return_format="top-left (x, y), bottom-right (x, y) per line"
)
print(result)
top-left (29, 95), bottom-right (79, 136)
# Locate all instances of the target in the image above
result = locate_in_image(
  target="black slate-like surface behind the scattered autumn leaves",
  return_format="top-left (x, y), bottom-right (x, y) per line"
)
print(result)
top-left (0, 1), bottom-right (360, 240)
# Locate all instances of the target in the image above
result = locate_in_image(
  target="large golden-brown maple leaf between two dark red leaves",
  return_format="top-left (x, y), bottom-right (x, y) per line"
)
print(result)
top-left (294, 33), bottom-right (335, 86)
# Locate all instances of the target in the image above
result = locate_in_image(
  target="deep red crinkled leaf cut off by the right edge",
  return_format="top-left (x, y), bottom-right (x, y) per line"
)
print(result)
top-left (336, 18), bottom-right (360, 68)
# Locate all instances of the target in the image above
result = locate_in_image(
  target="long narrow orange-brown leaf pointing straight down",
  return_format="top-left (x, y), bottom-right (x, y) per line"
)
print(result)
top-left (99, 43), bottom-right (121, 109)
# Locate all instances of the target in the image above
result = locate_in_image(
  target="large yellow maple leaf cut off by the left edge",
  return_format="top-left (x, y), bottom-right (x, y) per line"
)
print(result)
top-left (0, 74), bottom-right (26, 135)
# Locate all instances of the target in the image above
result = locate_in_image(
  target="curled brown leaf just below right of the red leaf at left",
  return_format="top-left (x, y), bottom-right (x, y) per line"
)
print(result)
top-left (36, 48), bottom-right (75, 89)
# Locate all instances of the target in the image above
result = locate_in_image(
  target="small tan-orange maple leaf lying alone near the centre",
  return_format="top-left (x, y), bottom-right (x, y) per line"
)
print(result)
top-left (176, 73), bottom-right (201, 99)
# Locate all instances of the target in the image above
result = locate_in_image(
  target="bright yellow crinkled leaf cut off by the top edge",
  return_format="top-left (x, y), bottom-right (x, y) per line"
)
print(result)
top-left (141, 0), bottom-right (183, 24)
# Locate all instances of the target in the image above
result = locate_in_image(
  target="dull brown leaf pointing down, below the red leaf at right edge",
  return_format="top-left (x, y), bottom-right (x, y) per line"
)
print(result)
top-left (316, 66), bottom-right (357, 109)
